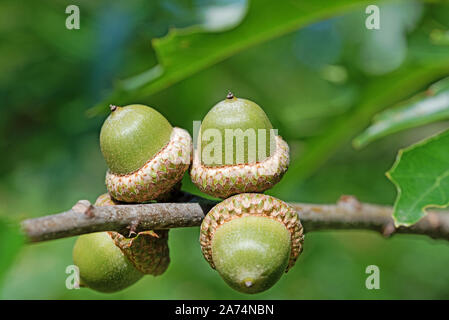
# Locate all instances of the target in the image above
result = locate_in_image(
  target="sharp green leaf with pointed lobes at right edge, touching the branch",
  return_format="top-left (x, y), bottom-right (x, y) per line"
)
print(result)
top-left (387, 130), bottom-right (449, 226)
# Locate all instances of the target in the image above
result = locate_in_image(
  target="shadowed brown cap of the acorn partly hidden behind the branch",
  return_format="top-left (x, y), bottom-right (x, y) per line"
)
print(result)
top-left (95, 193), bottom-right (170, 276)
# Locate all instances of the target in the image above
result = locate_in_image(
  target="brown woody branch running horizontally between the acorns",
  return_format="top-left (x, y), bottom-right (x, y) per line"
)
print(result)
top-left (22, 193), bottom-right (449, 242)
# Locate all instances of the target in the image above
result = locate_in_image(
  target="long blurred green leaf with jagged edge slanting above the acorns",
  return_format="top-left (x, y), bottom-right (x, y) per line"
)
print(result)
top-left (88, 0), bottom-right (388, 116)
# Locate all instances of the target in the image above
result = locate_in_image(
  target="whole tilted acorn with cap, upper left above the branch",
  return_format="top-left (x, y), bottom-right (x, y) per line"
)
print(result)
top-left (100, 104), bottom-right (192, 203)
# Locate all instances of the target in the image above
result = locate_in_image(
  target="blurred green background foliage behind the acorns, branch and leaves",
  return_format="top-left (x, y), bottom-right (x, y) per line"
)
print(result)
top-left (0, 0), bottom-right (449, 299)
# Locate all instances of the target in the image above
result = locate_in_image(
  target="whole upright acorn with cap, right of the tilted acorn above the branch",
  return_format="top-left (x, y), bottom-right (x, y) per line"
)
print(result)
top-left (190, 93), bottom-right (289, 199)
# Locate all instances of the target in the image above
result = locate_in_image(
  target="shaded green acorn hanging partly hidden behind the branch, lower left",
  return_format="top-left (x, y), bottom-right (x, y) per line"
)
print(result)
top-left (73, 194), bottom-right (170, 293)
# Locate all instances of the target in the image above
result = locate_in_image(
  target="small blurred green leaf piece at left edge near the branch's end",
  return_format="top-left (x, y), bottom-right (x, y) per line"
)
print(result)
top-left (0, 218), bottom-right (24, 288)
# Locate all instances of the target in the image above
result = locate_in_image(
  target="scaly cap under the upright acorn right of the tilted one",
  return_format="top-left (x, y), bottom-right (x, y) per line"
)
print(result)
top-left (190, 136), bottom-right (290, 199)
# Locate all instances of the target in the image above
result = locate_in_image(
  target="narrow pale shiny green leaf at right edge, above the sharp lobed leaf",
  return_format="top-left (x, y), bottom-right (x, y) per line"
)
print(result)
top-left (353, 78), bottom-right (449, 148)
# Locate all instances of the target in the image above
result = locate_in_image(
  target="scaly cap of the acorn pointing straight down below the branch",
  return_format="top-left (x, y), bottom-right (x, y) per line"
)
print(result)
top-left (200, 193), bottom-right (304, 272)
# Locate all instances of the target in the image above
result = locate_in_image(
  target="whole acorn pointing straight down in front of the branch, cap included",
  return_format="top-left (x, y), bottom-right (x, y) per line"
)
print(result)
top-left (200, 193), bottom-right (304, 293)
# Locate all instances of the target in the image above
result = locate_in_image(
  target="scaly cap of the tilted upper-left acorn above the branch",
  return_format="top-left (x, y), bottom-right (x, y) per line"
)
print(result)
top-left (106, 127), bottom-right (192, 202)
